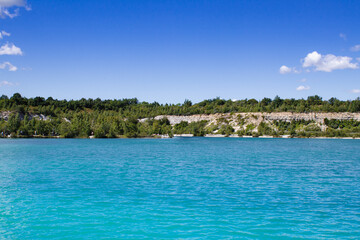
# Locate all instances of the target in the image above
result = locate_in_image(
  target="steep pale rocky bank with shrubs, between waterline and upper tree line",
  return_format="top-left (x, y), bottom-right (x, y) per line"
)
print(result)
top-left (0, 111), bottom-right (360, 138)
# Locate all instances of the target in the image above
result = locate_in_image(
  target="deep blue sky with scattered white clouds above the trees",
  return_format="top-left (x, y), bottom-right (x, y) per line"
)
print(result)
top-left (0, 0), bottom-right (360, 103)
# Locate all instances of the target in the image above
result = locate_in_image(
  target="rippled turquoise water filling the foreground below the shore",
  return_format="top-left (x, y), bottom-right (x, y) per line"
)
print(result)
top-left (0, 138), bottom-right (360, 239)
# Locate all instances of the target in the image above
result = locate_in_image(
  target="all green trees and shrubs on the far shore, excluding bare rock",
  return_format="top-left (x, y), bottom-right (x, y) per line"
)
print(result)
top-left (0, 93), bottom-right (360, 138)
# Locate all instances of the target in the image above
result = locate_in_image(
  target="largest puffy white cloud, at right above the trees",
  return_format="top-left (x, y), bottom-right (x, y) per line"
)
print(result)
top-left (303, 51), bottom-right (359, 72)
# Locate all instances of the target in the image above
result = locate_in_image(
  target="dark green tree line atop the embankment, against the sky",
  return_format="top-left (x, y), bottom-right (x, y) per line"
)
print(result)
top-left (0, 93), bottom-right (360, 118)
